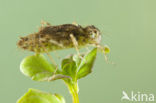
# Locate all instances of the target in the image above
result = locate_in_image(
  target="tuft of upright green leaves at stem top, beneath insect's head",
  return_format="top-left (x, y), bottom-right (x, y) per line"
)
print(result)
top-left (61, 48), bottom-right (97, 81)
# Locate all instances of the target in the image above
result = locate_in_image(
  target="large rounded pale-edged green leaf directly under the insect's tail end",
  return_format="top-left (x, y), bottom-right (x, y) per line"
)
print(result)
top-left (20, 55), bottom-right (66, 81)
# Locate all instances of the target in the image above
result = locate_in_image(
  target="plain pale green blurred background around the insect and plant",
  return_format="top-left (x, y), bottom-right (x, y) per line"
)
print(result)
top-left (0, 0), bottom-right (156, 103)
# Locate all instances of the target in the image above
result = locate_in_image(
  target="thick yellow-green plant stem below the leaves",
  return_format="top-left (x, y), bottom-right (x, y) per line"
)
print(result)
top-left (65, 82), bottom-right (79, 103)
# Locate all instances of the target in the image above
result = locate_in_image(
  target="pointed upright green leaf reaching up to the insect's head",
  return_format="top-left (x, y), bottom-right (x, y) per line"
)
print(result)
top-left (77, 48), bottom-right (97, 79)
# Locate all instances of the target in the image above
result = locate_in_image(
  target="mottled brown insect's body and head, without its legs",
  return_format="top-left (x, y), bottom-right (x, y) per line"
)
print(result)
top-left (17, 24), bottom-right (101, 53)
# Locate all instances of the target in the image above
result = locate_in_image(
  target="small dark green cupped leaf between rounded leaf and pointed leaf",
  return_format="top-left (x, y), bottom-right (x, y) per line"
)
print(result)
top-left (61, 57), bottom-right (77, 80)
